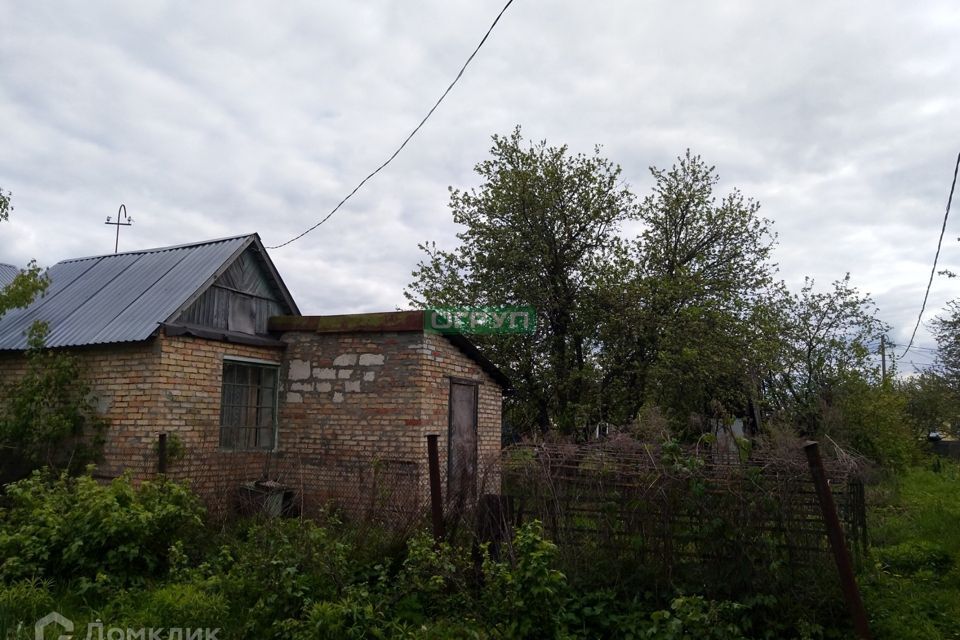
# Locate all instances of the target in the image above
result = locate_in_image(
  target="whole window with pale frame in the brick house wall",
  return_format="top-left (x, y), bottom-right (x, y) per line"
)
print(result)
top-left (220, 360), bottom-right (278, 450)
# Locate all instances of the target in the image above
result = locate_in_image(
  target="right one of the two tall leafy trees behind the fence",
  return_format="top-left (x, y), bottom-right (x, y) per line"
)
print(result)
top-left (600, 150), bottom-right (776, 424)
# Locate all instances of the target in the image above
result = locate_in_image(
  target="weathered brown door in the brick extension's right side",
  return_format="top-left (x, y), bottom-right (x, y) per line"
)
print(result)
top-left (447, 380), bottom-right (477, 505)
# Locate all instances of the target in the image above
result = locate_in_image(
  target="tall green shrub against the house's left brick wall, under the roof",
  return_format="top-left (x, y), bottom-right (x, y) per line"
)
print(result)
top-left (0, 323), bottom-right (106, 479)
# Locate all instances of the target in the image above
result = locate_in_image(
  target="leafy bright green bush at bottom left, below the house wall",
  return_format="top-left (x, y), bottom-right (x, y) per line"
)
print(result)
top-left (0, 472), bottom-right (203, 590)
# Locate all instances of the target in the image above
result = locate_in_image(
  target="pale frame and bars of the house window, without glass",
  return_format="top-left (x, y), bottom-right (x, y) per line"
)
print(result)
top-left (217, 355), bottom-right (280, 452)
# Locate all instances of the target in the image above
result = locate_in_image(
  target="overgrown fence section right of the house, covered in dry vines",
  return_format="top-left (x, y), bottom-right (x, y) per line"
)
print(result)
top-left (501, 438), bottom-right (866, 591)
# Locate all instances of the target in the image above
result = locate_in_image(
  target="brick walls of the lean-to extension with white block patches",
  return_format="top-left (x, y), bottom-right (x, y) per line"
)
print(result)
top-left (279, 331), bottom-right (502, 507)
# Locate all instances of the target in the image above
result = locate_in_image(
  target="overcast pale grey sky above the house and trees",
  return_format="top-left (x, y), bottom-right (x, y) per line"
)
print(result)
top-left (0, 0), bottom-right (960, 369)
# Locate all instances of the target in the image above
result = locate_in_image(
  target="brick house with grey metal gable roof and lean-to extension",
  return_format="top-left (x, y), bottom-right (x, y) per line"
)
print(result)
top-left (0, 234), bottom-right (509, 512)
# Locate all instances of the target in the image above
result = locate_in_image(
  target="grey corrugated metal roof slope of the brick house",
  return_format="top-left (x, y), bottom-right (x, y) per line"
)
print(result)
top-left (0, 235), bottom-right (256, 350)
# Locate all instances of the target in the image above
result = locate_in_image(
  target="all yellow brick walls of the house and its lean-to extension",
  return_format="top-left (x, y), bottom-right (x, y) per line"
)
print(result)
top-left (0, 332), bottom-right (501, 513)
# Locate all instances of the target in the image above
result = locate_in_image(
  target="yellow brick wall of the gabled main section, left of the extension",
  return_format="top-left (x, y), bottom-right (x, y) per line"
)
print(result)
top-left (0, 334), bottom-right (283, 508)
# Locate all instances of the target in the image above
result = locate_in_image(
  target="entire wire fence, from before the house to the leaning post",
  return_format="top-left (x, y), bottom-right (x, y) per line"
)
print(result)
top-left (154, 436), bottom-right (867, 591)
